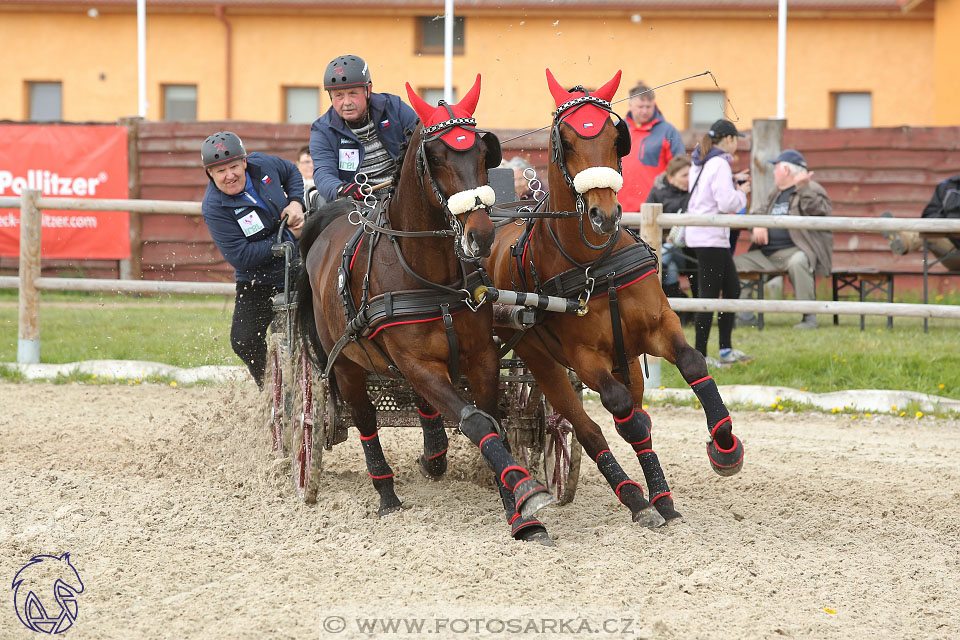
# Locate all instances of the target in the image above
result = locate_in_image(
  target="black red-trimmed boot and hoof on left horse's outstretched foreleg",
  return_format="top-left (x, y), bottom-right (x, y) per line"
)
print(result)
top-left (460, 404), bottom-right (556, 518)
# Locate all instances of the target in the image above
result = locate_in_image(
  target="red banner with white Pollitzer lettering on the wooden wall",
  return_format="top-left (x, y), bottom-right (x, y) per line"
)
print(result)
top-left (0, 124), bottom-right (130, 260)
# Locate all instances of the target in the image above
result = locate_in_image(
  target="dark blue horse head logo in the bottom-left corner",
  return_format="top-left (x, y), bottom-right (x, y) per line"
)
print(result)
top-left (10, 553), bottom-right (83, 634)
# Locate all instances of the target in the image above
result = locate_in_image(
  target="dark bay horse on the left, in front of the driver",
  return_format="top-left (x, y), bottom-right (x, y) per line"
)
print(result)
top-left (296, 75), bottom-right (553, 544)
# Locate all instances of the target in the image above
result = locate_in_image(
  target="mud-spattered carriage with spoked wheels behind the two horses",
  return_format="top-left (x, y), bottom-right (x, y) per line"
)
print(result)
top-left (263, 182), bottom-right (583, 504)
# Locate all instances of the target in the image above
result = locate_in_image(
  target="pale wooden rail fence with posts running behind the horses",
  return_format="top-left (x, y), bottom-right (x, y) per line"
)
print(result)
top-left (0, 190), bottom-right (960, 363)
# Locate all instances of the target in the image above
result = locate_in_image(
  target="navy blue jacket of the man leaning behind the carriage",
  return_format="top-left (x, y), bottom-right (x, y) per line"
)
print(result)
top-left (202, 152), bottom-right (303, 285)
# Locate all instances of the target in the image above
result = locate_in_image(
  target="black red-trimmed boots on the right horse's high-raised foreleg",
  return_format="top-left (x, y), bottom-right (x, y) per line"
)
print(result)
top-left (677, 345), bottom-right (743, 476)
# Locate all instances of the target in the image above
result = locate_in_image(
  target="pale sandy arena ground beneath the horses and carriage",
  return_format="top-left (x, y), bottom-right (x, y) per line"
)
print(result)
top-left (0, 383), bottom-right (960, 640)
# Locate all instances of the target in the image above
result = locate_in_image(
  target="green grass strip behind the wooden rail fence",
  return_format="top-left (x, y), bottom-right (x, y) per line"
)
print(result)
top-left (0, 291), bottom-right (960, 399)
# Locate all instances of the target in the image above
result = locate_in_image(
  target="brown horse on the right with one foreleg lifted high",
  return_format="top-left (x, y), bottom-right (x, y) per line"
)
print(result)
top-left (486, 69), bottom-right (743, 527)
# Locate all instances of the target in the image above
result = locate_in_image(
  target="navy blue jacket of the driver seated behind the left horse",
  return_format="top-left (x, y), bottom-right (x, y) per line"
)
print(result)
top-left (310, 93), bottom-right (419, 202)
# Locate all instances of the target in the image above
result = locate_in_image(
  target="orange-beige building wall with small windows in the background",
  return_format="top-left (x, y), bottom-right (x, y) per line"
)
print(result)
top-left (0, 0), bottom-right (940, 129)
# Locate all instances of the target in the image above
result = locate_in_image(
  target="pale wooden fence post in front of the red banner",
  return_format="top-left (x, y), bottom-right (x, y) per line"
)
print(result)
top-left (17, 189), bottom-right (41, 364)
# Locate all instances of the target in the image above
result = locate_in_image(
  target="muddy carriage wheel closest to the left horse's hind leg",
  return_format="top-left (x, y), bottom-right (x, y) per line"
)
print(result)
top-left (290, 349), bottom-right (329, 504)
